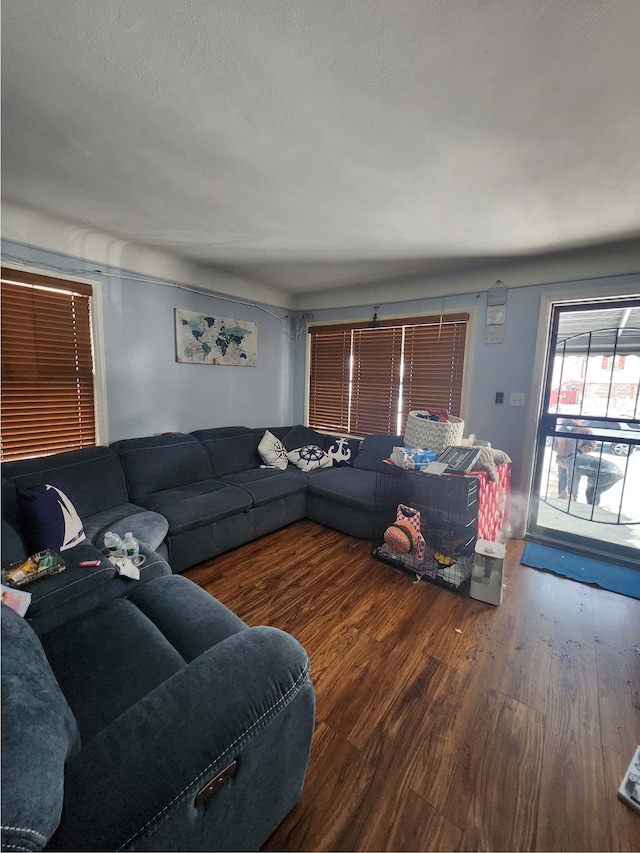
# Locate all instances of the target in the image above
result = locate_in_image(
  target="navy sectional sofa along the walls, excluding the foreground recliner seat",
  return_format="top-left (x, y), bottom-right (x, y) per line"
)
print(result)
top-left (2, 425), bottom-right (402, 634)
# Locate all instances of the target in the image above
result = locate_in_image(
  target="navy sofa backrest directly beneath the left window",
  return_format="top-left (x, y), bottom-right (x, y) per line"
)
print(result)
top-left (2, 446), bottom-right (129, 519)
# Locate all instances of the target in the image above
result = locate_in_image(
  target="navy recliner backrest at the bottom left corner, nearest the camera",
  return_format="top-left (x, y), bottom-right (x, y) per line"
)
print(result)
top-left (1, 605), bottom-right (79, 850)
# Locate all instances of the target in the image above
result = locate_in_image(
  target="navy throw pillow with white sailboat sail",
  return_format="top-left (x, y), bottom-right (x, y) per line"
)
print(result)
top-left (18, 483), bottom-right (86, 554)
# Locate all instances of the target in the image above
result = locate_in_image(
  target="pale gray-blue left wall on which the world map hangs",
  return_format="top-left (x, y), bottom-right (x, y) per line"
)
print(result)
top-left (2, 241), bottom-right (292, 442)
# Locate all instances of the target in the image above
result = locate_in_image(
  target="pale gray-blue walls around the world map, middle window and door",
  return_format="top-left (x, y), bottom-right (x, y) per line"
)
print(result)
top-left (3, 240), bottom-right (640, 510)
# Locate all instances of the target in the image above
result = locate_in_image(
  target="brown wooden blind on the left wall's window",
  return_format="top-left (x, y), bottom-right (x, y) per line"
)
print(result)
top-left (0, 268), bottom-right (96, 460)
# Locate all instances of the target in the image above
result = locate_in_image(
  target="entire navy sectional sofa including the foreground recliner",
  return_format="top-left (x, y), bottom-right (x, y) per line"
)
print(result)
top-left (1, 425), bottom-right (402, 851)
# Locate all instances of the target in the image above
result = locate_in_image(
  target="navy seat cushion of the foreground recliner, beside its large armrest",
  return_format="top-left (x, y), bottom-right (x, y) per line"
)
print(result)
top-left (42, 575), bottom-right (247, 744)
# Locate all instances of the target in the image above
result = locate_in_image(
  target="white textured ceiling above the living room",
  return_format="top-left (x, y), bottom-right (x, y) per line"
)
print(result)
top-left (2, 0), bottom-right (640, 293)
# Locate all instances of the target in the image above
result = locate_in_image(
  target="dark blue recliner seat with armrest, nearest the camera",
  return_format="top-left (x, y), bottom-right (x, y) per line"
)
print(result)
top-left (1, 575), bottom-right (315, 851)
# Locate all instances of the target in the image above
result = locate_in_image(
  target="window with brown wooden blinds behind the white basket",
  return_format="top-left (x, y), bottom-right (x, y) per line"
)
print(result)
top-left (309, 314), bottom-right (469, 435)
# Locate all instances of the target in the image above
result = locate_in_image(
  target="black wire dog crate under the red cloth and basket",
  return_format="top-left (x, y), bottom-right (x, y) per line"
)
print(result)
top-left (371, 464), bottom-right (479, 594)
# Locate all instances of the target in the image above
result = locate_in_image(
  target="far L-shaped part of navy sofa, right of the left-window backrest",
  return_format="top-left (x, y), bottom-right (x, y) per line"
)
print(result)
top-left (104, 425), bottom-right (402, 572)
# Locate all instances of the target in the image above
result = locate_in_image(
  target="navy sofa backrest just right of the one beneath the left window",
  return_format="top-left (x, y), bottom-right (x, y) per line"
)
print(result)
top-left (110, 432), bottom-right (211, 502)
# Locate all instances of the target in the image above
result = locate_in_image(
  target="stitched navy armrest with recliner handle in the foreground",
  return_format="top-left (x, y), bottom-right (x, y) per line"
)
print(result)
top-left (50, 627), bottom-right (315, 850)
